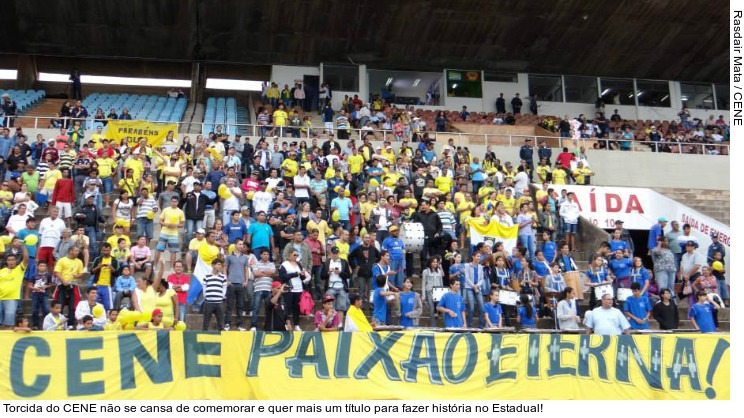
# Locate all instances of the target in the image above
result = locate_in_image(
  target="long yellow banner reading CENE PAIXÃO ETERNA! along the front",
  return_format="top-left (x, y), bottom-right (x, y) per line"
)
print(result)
top-left (0, 331), bottom-right (730, 400)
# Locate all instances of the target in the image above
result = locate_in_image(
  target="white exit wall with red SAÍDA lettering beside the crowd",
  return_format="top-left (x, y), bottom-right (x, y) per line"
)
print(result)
top-left (535, 184), bottom-right (731, 259)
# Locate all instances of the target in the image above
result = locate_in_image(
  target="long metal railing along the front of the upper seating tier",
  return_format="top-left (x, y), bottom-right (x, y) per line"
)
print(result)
top-left (8, 116), bottom-right (730, 155)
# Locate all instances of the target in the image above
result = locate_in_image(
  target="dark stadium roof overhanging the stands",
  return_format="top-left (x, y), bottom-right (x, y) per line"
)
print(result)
top-left (0, 0), bottom-right (729, 83)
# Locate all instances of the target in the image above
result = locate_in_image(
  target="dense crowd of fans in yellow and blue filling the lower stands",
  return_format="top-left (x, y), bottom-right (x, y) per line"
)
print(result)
top-left (0, 93), bottom-right (727, 332)
